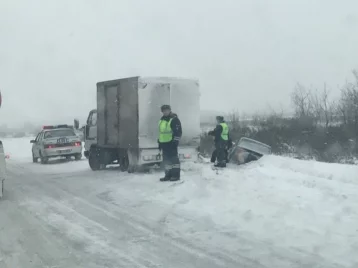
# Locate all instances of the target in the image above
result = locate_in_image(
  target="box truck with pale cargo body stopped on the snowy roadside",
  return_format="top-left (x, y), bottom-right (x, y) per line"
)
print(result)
top-left (84, 77), bottom-right (201, 172)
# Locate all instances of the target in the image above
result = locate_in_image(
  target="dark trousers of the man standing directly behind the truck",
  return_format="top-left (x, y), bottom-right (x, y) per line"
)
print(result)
top-left (161, 143), bottom-right (180, 178)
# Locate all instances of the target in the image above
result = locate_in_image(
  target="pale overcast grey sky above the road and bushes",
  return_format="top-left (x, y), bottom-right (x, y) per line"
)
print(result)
top-left (0, 0), bottom-right (358, 124)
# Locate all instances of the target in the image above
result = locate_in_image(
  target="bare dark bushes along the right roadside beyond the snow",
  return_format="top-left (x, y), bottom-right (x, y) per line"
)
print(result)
top-left (200, 71), bottom-right (358, 164)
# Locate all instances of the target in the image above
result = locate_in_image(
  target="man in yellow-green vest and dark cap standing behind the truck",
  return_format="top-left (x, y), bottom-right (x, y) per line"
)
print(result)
top-left (158, 105), bottom-right (182, 181)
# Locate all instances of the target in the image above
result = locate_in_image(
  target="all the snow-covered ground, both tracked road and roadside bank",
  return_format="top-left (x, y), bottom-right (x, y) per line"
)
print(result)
top-left (0, 139), bottom-right (358, 268)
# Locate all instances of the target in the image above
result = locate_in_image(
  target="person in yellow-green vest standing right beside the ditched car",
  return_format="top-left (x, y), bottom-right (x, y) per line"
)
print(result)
top-left (208, 116), bottom-right (231, 167)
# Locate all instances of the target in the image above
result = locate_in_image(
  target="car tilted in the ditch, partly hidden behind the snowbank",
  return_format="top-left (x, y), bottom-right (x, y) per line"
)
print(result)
top-left (228, 138), bottom-right (271, 165)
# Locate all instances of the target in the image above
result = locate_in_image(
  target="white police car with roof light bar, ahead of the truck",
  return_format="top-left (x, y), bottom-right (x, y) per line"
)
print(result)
top-left (30, 125), bottom-right (82, 164)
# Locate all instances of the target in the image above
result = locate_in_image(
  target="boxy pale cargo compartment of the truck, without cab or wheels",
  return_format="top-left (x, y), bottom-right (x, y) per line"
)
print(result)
top-left (97, 77), bottom-right (200, 149)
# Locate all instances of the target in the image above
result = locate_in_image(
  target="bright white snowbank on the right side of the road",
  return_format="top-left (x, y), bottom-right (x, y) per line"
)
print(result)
top-left (108, 156), bottom-right (358, 267)
